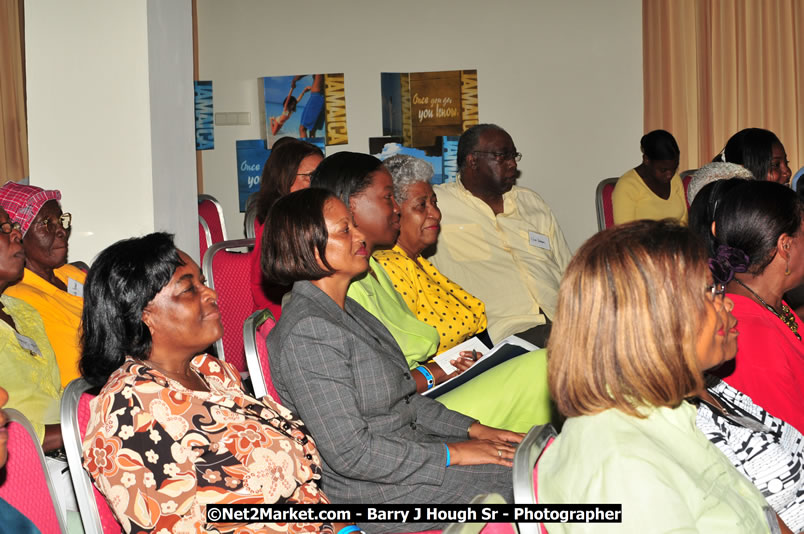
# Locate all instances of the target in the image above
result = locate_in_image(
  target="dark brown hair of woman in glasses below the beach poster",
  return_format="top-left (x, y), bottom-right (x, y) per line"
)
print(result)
top-left (255, 137), bottom-right (324, 224)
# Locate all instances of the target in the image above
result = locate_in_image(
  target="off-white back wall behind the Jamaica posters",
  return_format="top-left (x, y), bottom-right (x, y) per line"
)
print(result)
top-left (197, 0), bottom-right (643, 249)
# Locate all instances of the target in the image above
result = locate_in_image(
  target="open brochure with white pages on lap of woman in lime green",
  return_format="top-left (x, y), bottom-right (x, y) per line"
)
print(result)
top-left (422, 336), bottom-right (539, 399)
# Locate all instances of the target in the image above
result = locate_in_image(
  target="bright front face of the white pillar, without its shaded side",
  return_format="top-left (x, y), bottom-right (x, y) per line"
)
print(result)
top-left (25, 0), bottom-right (153, 261)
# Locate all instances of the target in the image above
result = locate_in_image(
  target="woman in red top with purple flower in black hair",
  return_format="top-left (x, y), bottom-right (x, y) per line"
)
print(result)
top-left (690, 180), bottom-right (804, 431)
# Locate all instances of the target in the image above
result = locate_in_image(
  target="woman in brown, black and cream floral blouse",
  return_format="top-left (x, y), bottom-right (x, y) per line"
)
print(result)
top-left (81, 233), bottom-right (348, 532)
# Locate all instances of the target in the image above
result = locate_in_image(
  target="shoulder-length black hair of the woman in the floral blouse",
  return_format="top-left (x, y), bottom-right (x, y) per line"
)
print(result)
top-left (79, 232), bottom-right (183, 386)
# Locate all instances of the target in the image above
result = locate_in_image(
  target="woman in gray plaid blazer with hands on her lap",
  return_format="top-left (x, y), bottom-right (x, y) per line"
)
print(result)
top-left (262, 188), bottom-right (522, 532)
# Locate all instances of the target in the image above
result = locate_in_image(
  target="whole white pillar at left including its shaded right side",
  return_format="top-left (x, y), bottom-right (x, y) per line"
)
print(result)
top-left (25, 0), bottom-right (198, 262)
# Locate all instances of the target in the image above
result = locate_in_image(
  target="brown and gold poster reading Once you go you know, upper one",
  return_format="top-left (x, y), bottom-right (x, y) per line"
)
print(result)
top-left (380, 70), bottom-right (478, 147)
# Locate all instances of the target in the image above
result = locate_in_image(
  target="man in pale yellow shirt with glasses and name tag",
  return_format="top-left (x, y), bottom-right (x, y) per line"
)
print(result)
top-left (430, 124), bottom-right (571, 347)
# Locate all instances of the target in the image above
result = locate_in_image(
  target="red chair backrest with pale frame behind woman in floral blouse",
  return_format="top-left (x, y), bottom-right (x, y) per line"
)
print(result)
top-left (61, 378), bottom-right (122, 534)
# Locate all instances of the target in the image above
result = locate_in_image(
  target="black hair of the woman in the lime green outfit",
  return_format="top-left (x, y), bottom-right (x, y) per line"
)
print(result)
top-left (310, 152), bottom-right (382, 208)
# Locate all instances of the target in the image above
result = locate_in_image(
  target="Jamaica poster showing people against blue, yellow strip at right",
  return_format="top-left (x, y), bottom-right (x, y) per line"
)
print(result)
top-left (259, 73), bottom-right (349, 147)
